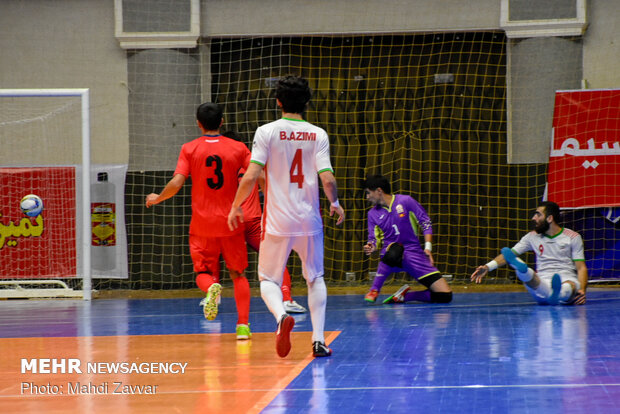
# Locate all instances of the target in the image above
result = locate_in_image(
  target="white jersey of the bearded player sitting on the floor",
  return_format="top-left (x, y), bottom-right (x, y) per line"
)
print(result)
top-left (512, 228), bottom-right (585, 280)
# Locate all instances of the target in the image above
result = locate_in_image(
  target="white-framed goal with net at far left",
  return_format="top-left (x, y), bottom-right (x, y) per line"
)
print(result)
top-left (0, 89), bottom-right (91, 299)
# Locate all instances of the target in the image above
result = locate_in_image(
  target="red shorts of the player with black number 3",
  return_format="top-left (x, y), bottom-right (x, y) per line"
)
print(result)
top-left (189, 233), bottom-right (248, 276)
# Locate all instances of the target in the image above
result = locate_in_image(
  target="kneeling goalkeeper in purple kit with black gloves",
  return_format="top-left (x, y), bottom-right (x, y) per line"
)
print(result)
top-left (364, 175), bottom-right (452, 303)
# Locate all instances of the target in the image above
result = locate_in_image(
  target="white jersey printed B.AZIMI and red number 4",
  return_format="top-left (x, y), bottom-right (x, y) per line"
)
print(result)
top-left (251, 118), bottom-right (333, 236)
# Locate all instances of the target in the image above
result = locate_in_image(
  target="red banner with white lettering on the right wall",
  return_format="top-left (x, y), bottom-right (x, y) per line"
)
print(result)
top-left (547, 89), bottom-right (620, 208)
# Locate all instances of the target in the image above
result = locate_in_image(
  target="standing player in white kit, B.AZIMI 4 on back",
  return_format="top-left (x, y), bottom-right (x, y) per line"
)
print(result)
top-left (228, 76), bottom-right (344, 357)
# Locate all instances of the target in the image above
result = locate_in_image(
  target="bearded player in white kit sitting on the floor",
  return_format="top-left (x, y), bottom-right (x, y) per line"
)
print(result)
top-left (471, 201), bottom-right (588, 305)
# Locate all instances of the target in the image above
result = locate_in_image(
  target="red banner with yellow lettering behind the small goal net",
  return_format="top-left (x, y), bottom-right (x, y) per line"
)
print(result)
top-left (0, 167), bottom-right (77, 279)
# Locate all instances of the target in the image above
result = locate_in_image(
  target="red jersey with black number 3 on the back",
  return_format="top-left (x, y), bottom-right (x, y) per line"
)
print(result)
top-left (174, 135), bottom-right (251, 237)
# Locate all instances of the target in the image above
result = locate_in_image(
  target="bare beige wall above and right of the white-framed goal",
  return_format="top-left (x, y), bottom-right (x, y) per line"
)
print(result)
top-left (0, 0), bottom-right (129, 164)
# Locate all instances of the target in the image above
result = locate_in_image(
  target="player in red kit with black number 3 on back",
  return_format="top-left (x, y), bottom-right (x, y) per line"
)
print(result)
top-left (146, 103), bottom-right (252, 339)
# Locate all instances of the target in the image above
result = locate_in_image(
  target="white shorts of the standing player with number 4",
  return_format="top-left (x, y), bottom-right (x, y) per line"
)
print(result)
top-left (258, 232), bottom-right (324, 286)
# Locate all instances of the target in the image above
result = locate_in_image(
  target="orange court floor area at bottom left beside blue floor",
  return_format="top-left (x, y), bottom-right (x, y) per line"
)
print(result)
top-left (0, 332), bottom-right (339, 414)
